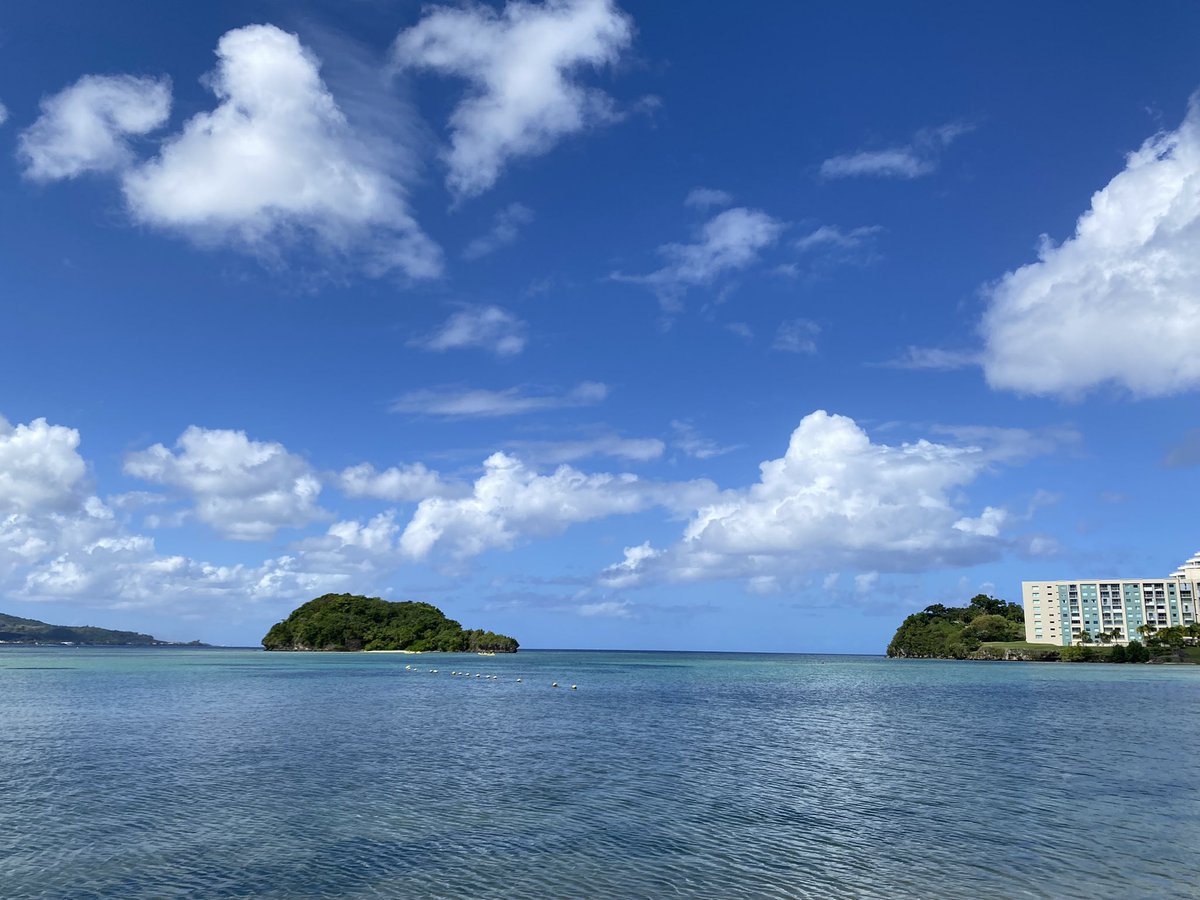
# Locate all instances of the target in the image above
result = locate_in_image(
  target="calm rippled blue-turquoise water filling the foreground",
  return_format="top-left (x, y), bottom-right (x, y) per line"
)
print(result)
top-left (0, 648), bottom-right (1200, 899)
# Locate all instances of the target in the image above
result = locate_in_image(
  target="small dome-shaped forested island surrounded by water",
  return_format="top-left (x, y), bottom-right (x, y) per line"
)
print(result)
top-left (263, 594), bottom-right (518, 653)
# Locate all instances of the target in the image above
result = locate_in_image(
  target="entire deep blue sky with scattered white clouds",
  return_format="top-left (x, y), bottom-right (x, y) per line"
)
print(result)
top-left (0, 0), bottom-right (1200, 653)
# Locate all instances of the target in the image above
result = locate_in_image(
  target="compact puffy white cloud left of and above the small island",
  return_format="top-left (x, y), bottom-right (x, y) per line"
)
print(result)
top-left (125, 425), bottom-right (325, 540)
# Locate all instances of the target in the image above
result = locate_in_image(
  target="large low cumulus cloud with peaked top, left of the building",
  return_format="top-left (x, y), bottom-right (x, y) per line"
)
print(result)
top-left (601, 410), bottom-right (1022, 587)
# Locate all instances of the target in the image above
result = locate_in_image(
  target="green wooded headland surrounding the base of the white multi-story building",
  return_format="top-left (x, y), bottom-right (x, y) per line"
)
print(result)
top-left (887, 594), bottom-right (1200, 662)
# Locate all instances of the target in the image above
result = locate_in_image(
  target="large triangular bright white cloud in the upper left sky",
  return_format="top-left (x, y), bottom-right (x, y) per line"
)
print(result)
top-left (124, 25), bottom-right (442, 277)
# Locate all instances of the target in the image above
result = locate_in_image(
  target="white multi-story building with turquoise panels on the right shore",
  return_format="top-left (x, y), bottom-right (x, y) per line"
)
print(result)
top-left (1021, 553), bottom-right (1200, 647)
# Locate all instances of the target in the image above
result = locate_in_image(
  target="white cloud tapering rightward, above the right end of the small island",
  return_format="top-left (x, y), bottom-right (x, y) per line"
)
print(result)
top-left (400, 454), bottom-right (713, 559)
